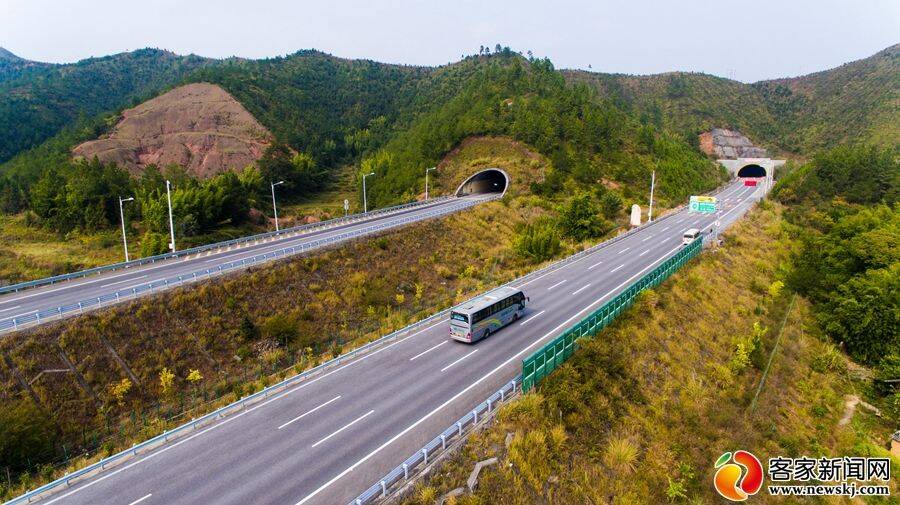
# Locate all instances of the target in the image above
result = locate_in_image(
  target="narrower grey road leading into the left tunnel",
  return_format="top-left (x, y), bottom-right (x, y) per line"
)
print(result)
top-left (0, 196), bottom-right (484, 332)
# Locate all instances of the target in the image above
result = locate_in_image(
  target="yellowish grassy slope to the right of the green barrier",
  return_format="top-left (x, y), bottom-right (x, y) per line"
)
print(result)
top-left (405, 203), bottom-right (898, 504)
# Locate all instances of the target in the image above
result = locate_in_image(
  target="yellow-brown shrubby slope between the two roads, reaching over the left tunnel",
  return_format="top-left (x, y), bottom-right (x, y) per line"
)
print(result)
top-left (0, 137), bottom-right (696, 497)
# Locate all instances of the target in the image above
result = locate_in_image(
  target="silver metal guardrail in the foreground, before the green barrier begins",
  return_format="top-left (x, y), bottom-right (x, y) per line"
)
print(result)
top-left (349, 375), bottom-right (522, 505)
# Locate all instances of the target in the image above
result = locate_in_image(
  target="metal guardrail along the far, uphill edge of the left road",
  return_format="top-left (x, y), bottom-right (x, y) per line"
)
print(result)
top-left (0, 196), bottom-right (451, 295)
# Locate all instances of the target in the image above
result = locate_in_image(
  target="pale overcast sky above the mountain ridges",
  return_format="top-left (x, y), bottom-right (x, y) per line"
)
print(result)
top-left (0, 0), bottom-right (900, 82)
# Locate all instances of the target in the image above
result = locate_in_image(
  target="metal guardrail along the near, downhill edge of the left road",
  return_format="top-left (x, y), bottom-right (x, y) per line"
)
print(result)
top-left (0, 200), bottom-right (484, 334)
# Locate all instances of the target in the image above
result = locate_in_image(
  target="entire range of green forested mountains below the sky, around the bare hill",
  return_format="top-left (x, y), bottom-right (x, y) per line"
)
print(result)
top-left (0, 45), bottom-right (900, 256)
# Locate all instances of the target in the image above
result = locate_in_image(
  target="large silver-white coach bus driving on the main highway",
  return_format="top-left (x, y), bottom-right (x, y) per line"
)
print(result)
top-left (450, 287), bottom-right (528, 343)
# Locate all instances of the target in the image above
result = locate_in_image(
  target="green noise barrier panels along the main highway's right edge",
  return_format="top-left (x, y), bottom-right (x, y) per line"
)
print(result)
top-left (522, 240), bottom-right (703, 392)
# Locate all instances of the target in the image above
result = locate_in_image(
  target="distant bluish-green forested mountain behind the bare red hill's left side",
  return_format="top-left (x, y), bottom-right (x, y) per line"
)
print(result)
top-left (0, 49), bottom-right (211, 162)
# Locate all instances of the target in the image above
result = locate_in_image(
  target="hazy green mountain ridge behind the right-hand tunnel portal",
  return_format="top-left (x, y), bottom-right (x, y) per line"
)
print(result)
top-left (565, 45), bottom-right (900, 154)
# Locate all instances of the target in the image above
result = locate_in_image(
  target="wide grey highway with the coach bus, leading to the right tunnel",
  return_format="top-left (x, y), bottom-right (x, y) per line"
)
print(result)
top-left (26, 182), bottom-right (763, 505)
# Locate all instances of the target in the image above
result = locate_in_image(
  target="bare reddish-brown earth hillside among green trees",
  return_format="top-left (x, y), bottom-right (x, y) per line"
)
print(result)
top-left (73, 83), bottom-right (272, 177)
